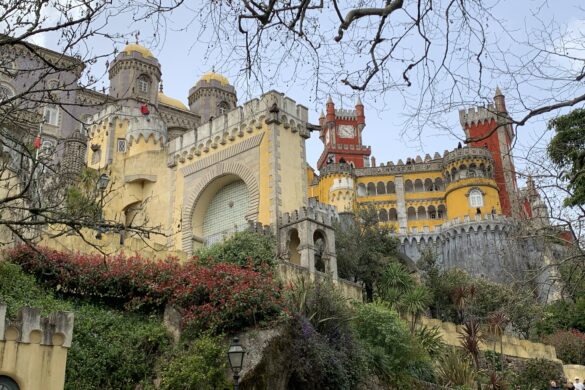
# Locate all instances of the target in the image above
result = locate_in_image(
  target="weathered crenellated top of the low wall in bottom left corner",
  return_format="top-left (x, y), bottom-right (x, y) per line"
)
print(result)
top-left (0, 303), bottom-right (73, 348)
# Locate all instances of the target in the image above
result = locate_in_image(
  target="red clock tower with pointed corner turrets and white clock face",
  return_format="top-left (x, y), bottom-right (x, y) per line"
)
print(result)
top-left (317, 96), bottom-right (371, 169)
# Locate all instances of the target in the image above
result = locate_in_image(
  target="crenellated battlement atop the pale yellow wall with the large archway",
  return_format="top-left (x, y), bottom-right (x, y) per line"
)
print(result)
top-left (168, 91), bottom-right (309, 165)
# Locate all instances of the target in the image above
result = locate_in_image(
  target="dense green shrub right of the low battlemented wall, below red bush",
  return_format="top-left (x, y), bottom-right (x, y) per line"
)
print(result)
top-left (65, 305), bottom-right (170, 390)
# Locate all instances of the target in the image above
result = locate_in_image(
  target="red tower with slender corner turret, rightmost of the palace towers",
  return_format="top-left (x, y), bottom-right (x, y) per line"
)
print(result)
top-left (459, 88), bottom-right (520, 217)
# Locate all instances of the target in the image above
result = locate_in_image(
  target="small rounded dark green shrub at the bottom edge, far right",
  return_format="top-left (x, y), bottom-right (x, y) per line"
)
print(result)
top-left (513, 359), bottom-right (564, 390)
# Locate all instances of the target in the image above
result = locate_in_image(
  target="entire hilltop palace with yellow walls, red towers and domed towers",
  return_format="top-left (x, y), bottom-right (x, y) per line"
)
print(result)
top-left (0, 44), bottom-right (549, 292)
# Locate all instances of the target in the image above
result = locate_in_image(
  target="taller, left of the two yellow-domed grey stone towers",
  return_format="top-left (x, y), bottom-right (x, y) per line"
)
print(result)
top-left (109, 43), bottom-right (162, 106)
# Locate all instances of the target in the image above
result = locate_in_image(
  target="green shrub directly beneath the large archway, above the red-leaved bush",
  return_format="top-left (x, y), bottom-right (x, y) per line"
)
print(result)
top-left (195, 231), bottom-right (276, 269)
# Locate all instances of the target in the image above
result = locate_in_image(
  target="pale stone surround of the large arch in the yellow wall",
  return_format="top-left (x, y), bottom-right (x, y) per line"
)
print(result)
top-left (181, 163), bottom-right (260, 254)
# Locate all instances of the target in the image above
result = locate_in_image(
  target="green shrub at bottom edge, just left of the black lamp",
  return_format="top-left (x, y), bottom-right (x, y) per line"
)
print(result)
top-left (161, 335), bottom-right (229, 390)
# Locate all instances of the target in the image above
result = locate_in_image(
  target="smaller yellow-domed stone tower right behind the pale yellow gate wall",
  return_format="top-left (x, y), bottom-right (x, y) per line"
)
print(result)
top-left (189, 72), bottom-right (238, 123)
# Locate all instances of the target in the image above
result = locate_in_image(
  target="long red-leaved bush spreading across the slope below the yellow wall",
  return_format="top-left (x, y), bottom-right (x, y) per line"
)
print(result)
top-left (5, 246), bottom-right (283, 332)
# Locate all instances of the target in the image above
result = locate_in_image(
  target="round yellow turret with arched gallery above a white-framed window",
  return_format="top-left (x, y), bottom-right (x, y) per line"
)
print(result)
top-left (443, 147), bottom-right (501, 220)
